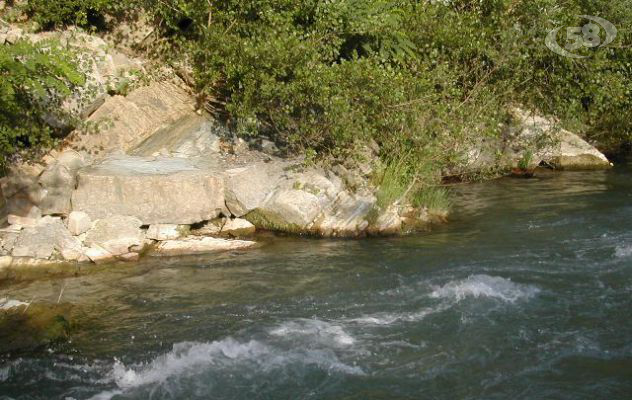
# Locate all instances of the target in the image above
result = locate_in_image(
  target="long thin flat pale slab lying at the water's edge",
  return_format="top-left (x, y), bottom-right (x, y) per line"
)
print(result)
top-left (155, 237), bottom-right (256, 256)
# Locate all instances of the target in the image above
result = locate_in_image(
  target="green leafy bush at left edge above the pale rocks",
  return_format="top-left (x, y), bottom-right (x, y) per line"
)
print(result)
top-left (0, 41), bottom-right (84, 167)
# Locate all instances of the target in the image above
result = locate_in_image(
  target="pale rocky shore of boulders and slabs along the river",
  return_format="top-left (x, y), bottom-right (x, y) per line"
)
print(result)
top-left (0, 27), bottom-right (610, 268)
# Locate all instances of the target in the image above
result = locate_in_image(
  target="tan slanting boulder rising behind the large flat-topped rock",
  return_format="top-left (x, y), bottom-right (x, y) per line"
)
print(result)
top-left (66, 82), bottom-right (194, 156)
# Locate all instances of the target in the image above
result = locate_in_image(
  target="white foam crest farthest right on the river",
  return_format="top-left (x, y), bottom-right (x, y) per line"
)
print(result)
top-left (430, 275), bottom-right (540, 303)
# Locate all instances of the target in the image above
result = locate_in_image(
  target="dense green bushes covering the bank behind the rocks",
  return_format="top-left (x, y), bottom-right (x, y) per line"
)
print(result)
top-left (1, 0), bottom-right (632, 209)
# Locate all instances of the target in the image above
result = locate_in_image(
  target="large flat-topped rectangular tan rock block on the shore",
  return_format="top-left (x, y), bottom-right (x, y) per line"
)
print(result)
top-left (72, 156), bottom-right (225, 225)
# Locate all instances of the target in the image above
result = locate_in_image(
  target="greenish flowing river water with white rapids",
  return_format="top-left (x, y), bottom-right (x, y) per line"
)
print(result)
top-left (0, 167), bottom-right (632, 400)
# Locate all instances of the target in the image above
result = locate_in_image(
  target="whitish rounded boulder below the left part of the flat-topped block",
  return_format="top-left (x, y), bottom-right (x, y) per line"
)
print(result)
top-left (84, 215), bottom-right (145, 261)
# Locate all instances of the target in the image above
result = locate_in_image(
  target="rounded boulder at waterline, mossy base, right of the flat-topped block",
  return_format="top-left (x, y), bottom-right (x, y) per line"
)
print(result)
top-left (246, 189), bottom-right (322, 233)
